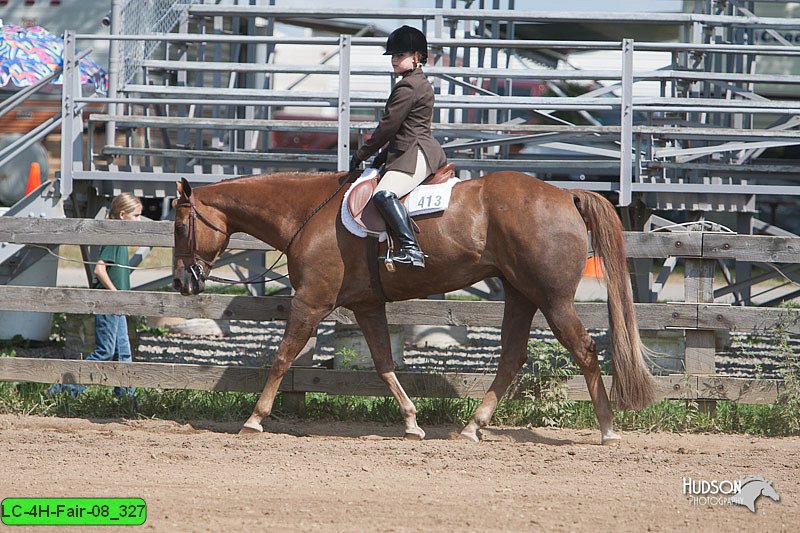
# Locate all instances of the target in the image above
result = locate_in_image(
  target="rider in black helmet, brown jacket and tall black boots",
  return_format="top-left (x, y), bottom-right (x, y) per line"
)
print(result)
top-left (350, 26), bottom-right (447, 268)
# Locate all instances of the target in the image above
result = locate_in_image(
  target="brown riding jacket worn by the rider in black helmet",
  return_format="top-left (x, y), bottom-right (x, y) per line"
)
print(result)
top-left (356, 67), bottom-right (447, 174)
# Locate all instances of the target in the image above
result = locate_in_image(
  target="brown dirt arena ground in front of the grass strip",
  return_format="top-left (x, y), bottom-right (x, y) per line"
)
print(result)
top-left (0, 416), bottom-right (800, 532)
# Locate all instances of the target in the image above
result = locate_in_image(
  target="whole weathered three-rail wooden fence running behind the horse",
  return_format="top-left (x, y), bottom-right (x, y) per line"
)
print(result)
top-left (0, 217), bottom-right (800, 403)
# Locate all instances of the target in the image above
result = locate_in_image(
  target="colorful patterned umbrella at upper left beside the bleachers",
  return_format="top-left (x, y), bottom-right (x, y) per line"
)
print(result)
top-left (0, 24), bottom-right (108, 94)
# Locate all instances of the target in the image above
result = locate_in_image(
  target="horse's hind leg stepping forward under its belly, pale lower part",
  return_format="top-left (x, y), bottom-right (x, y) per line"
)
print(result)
top-left (460, 283), bottom-right (536, 442)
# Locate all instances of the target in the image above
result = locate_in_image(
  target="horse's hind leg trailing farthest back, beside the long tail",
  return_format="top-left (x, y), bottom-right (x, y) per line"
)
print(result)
top-left (542, 300), bottom-right (620, 444)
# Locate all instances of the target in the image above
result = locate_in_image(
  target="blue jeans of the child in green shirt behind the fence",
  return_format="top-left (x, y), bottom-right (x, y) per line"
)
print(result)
top-left (50, 315), bottom-right (136, 397)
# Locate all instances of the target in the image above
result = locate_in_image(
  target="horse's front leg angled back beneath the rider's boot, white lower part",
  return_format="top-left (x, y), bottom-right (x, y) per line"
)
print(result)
top-left (353, 304), bottom-right (425, 440)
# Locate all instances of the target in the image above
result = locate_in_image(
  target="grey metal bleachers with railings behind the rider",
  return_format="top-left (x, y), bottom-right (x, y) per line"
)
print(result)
top-left (48, 5), bottom-right (800, 210)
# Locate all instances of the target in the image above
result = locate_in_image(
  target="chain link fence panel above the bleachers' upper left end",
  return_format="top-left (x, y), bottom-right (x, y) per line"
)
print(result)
top-left (120, 0), bottom-right (202, 85)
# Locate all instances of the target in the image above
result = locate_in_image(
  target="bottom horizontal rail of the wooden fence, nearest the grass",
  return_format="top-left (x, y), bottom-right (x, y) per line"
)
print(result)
top-left (0, 357), bottom-right (783, 403)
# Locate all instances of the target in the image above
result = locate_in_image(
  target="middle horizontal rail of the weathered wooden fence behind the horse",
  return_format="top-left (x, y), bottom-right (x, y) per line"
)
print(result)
top-left (0, 285), bottom-right (800, 333)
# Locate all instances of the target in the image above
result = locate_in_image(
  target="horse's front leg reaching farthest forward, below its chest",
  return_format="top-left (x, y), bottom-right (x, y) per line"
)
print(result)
top-left (239, 295), bottom-right (330, 435)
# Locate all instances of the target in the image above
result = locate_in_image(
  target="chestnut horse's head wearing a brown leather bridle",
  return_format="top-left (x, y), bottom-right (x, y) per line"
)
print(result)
top-left (172, 178), bottom-right (229, 295)
